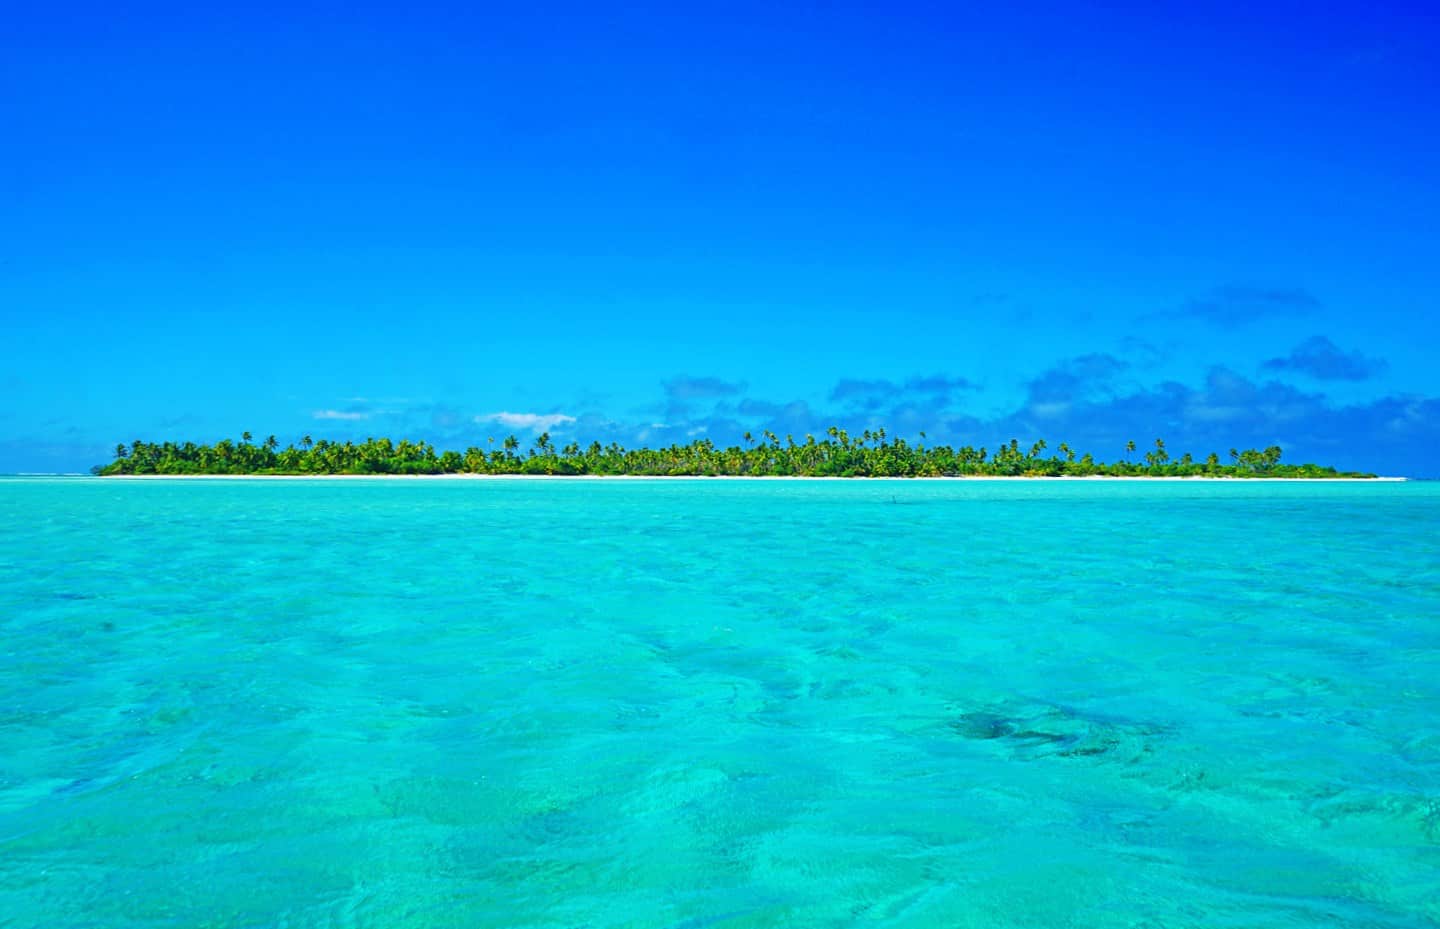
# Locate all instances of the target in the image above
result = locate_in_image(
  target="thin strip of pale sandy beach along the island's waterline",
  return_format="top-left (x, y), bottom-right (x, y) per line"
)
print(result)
top-left (87, 474), bottom-right (1410, 484)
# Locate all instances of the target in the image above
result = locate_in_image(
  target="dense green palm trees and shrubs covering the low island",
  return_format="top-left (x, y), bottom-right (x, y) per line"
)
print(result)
top-left (94, 426), bottom-right (1375, 478)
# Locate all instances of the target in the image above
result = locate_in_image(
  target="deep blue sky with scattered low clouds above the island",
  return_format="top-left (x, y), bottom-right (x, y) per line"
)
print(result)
top-left (0, 3), bottom-right (1440, 475)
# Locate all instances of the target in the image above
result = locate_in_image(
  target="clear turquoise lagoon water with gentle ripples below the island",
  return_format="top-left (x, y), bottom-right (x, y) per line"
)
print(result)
top-left (0, 478), bottom-right (1440, 929)
